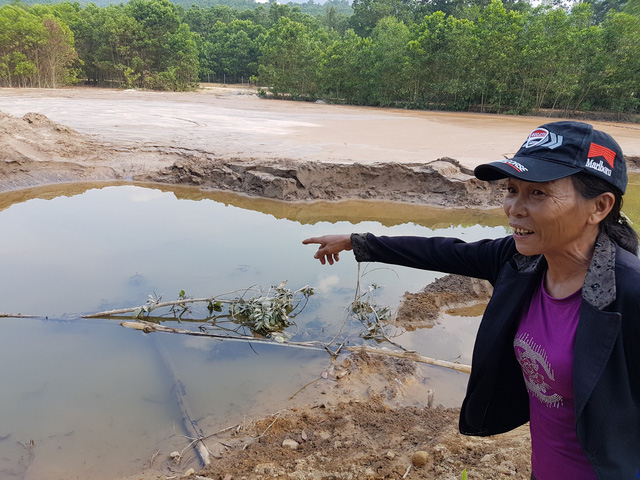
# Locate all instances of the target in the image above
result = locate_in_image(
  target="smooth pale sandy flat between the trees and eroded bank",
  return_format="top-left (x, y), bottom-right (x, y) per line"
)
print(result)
top-left (0, 86), bottom-right (640, 171)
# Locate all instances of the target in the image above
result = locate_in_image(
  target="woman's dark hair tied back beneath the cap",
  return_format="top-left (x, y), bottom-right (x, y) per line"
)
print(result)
top-left (570, 172), bottom-right (638, 255)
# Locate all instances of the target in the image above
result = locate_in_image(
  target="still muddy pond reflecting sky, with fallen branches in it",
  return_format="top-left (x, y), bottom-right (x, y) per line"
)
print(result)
top-left (0, 180), bottom-right (640, 480)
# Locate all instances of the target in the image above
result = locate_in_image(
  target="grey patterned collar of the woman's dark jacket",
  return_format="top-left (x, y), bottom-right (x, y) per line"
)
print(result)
top-left (513, 233), bottom-right (616, 310)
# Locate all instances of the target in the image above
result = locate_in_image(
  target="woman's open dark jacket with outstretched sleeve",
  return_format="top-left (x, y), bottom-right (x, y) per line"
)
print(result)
top-left (352, 234), bottom-right (640, 480)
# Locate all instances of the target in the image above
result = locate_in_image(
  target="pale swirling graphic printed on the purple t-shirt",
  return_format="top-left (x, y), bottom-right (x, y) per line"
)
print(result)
top-left (513, 332), bottom-right (562, 408)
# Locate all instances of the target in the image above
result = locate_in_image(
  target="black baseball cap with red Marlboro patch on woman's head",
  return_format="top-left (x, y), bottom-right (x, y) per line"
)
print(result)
top-left (474, 122), bottom-right (627, 193)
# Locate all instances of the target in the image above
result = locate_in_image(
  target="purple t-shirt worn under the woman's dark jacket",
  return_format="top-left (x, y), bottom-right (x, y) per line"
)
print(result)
top-left (513, 279), bottom-right (597, 480)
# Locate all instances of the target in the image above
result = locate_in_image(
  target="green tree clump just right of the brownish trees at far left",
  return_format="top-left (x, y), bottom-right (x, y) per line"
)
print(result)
top-left (75, 0), bottom-right (198, 90)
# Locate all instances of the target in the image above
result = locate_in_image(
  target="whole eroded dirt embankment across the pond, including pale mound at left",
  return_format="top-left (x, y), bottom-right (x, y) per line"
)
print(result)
top-left (0, 113), bottom-right (500, 207)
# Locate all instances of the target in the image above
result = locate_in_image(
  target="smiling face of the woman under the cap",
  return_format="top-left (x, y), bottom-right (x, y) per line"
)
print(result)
top-left (504, 177), bottom-right (598, 257)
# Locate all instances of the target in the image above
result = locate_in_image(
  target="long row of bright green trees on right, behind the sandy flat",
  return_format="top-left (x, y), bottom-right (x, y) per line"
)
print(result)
top-left (259, 0), bottom-right (640, 115)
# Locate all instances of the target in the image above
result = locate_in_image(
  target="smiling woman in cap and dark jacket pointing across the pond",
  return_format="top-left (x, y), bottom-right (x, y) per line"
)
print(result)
top-left (303, 122), bottom-right (640, 480)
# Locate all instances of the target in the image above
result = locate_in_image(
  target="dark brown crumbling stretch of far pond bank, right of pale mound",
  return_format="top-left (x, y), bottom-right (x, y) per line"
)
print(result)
top-left (140, 154), bottom-right (501, 207)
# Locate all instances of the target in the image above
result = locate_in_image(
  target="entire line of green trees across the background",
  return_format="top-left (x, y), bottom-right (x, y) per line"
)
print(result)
top-left (0, 0), bottom-right (640, 116)
